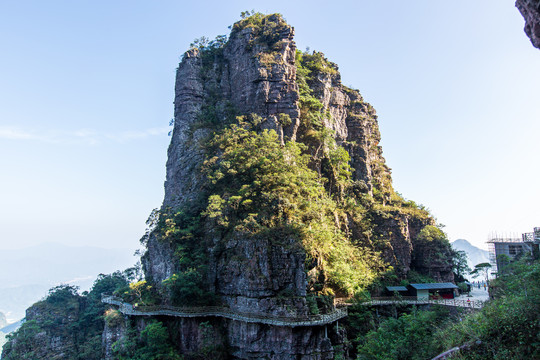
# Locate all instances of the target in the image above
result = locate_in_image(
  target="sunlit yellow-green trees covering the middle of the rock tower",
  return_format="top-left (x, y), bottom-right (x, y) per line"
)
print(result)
top-left (204, 122), bottom-right (383, 294)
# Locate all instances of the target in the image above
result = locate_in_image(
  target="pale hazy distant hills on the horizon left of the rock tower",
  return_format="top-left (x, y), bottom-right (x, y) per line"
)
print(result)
top-left (0, 243), bottom-right (136, 322)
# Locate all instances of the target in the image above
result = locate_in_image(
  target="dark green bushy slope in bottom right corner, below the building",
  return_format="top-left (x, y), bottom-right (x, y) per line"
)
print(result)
top-left (438, 258), bottom-right (540, 360)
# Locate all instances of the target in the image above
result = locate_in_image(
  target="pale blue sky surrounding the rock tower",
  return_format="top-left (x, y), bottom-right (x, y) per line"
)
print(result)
top-left (0, 0), bottom-right (540, 253)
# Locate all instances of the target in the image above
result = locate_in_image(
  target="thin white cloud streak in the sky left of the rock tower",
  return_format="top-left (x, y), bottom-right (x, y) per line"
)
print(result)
top-left (0, 126), bottom-right (169, 145)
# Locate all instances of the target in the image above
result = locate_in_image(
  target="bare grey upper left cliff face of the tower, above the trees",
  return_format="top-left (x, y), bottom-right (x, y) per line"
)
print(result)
top-left (163, 16), bottom-right (299, 208)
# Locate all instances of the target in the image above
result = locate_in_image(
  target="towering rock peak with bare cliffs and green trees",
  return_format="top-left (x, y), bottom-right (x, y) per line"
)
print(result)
top-left (137, 13), bottom-right (453, 353)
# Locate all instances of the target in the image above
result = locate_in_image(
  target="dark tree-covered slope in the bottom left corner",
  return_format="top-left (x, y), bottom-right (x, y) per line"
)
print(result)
top-left (3, 272), bottom-right (129, 360)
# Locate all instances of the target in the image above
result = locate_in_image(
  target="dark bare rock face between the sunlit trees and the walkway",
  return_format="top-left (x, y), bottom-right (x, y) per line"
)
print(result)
top-left (210, 234), bottom-right (307, 316)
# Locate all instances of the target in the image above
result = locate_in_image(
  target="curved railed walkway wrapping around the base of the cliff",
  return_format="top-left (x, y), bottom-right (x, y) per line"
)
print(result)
top-left (101, 294), bottom-right (347, 327)
